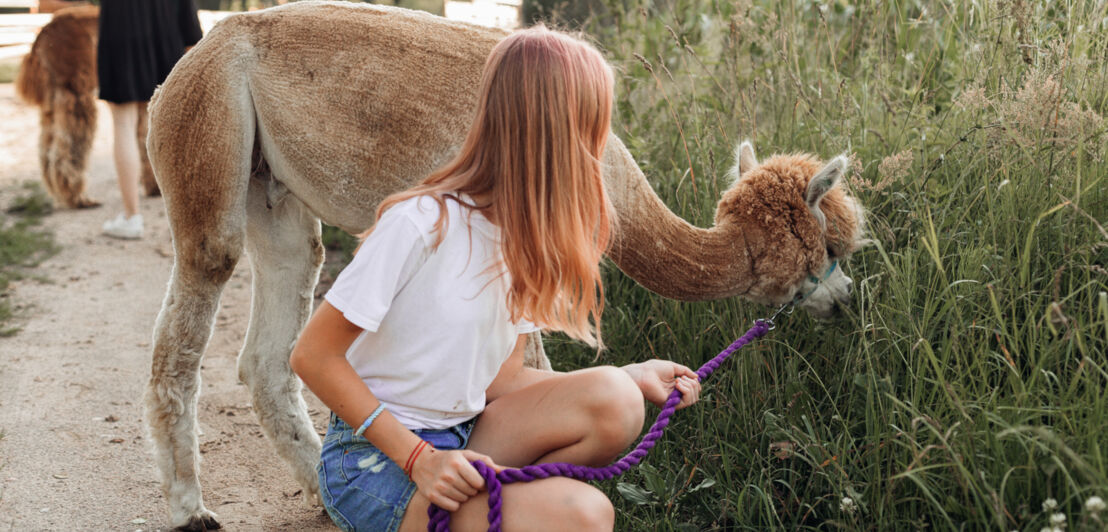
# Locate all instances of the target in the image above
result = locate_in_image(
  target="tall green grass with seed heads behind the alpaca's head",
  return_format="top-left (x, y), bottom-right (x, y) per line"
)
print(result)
top-left (531, 0), bottom-right (1108, 530)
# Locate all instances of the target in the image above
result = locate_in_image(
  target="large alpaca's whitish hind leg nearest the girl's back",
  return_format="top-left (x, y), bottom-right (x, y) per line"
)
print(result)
top-left (238, 180), bottom-right (324, 503)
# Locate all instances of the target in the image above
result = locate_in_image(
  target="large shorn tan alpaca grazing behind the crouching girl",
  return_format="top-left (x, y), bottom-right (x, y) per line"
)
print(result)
top-left (145, 1), bottom-right (863, 530)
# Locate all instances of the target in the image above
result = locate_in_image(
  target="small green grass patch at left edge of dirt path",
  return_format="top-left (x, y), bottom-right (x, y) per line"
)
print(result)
top-left (0, 182), bottom-right (57, 336)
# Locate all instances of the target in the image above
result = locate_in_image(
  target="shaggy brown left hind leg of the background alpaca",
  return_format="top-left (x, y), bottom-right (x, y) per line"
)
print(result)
top-left (44, 90), bottom-right (100, 208)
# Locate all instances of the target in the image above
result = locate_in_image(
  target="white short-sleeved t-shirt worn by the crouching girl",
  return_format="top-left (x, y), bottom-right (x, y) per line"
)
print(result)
top-left (325, 192), bottom-right (536, 429)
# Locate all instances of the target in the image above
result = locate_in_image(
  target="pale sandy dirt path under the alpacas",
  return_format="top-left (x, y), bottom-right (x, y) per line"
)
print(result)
top-left (0, 84), bottom-right (335, 531)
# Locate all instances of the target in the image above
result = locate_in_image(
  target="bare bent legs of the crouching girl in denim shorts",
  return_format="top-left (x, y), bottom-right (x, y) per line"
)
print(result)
top-left (401, 367), bottom-right (645, 531)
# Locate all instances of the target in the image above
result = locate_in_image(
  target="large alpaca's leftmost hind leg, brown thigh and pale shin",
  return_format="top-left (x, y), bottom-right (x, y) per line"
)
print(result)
top-left (142, 67), bottom-right (256, 531)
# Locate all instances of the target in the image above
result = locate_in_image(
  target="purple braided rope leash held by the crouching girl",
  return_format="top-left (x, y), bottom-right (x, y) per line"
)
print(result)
top-left (427, 316), bottom-right (771, 532)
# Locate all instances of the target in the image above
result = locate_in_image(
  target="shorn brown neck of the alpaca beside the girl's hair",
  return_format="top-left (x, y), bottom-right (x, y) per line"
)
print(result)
top-left (604, 135), bottom-right (753, 301)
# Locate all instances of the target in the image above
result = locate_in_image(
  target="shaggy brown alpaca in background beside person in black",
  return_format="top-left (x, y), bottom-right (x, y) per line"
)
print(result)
top-left (16, 6), bottom-right (158, 208)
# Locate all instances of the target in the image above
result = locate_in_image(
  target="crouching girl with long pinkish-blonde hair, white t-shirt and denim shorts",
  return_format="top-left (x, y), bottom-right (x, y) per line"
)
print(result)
top-left (290, 28), bottom-right (700, 531)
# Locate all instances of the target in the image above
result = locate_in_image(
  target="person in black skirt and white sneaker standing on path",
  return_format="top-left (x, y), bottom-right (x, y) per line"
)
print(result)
top-left (96, 0), bottom-right (203, 238)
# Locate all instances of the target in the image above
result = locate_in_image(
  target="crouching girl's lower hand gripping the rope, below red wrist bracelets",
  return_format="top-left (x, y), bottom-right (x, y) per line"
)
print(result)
top-left (412, 448), bottom-right (504, 512)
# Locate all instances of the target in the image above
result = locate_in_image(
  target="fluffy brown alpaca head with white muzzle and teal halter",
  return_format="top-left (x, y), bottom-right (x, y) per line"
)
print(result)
top-left (716, 142), bottom-right (865, 318)
